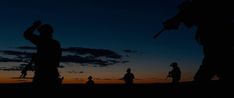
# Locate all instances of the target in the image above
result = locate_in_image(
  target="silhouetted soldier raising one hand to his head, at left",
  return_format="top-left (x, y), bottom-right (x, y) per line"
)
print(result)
top-left (24, 21), bottom-right (62, 89)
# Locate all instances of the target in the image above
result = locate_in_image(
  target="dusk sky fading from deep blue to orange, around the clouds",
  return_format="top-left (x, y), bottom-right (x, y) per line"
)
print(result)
top-left (0, 0), bottom-right (203, 83)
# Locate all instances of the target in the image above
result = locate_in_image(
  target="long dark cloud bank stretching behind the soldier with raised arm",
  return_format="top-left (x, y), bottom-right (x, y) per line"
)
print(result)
top-left (0, 46), bottom-right (128, 67)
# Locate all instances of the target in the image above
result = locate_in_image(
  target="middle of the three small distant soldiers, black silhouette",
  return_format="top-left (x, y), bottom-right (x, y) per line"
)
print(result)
top-left (123, 68), bottom-right (135, 88)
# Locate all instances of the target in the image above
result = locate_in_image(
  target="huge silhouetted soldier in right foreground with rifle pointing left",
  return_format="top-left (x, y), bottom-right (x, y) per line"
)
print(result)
top-left (155, 0), bottom-right (234, 82)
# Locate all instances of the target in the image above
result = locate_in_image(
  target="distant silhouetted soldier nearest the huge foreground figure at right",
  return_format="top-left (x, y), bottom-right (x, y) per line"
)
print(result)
top-left (167, 62), bottom-right (181, 84)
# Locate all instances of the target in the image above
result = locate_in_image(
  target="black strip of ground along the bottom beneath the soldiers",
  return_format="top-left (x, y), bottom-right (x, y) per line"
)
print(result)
top-left (0, 81), bottom-right (230, 98)
